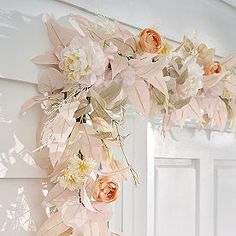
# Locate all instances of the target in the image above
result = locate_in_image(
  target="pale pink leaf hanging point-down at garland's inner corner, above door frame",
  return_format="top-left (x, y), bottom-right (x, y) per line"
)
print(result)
top-left (127, 80), bottom-right (150, 116)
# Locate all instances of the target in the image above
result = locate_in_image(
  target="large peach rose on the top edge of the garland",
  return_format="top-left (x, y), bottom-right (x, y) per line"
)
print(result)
top-left (137, 28), bottom-right (163, 53)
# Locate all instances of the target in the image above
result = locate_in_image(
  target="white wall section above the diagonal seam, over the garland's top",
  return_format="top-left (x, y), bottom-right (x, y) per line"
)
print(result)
top-left (64, 0), bottom-right (236, 55)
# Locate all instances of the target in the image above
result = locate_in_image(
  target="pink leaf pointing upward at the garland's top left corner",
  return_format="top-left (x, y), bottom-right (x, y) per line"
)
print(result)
top-left (46, 17), bottom-right (78, 48)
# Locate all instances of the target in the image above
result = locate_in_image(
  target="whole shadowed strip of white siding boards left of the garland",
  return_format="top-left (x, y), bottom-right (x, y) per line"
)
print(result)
top-left (0, 12), bottom-right (54, 233)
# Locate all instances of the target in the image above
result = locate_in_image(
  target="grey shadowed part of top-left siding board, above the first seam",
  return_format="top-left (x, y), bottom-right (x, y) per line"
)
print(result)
top-left (0, 10), bottom-right (72, 83)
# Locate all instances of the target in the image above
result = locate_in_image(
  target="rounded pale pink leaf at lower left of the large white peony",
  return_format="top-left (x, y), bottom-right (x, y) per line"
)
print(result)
top-left (38, 68), bottom-right (64, 93)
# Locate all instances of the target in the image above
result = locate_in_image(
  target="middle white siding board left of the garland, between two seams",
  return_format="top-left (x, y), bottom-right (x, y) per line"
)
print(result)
top-left (0, 79), bottom-right (43, 178)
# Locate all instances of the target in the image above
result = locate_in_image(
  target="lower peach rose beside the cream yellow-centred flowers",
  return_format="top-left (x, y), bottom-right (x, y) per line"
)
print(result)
top-left (93, 176), bottom-right (119, 203)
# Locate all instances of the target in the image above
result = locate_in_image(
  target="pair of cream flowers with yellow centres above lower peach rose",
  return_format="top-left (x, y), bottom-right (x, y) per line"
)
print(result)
top-left (58, 156), bottom-right (96, 191)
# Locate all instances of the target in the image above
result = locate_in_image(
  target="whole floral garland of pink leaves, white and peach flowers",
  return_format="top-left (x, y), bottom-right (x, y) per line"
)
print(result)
top-left (21, 13), bottom-right (236, 236)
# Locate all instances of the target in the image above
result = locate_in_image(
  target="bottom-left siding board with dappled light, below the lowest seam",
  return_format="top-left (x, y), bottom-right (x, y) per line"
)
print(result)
top-left (0, 179), bottom-right (47, 236)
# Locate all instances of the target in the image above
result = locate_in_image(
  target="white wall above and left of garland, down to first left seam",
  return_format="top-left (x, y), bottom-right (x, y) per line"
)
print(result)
top-left (0, 0), bottom-right (236, 85)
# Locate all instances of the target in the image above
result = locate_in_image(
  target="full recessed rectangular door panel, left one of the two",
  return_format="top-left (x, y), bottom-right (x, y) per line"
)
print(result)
top-left (155, 159), bottom-right (198, 236)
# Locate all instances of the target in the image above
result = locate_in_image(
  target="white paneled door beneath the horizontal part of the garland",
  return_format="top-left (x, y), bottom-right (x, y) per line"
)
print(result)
top-left (148, 127), bottom-right (236, 236)
